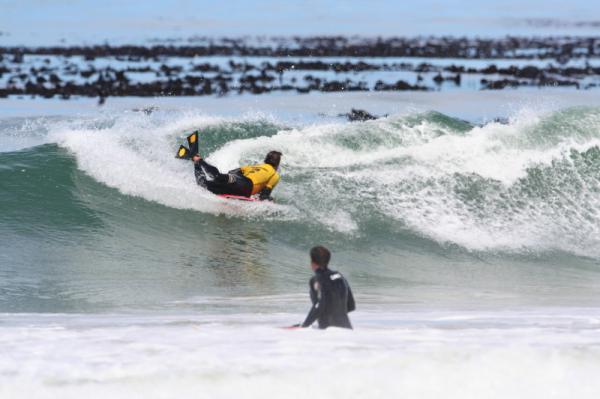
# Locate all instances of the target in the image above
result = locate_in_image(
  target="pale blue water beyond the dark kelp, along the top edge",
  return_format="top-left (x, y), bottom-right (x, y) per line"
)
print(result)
top-left (0, 0), bottom-right (600, 46)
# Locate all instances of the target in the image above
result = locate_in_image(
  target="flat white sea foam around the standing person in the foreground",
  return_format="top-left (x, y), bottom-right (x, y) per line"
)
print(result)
top-left (0, 310), bottom-right (600, 399)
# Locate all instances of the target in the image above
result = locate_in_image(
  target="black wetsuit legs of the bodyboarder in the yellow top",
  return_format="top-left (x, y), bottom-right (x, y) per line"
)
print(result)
top-left (194, 159), bottom-right (253, 197)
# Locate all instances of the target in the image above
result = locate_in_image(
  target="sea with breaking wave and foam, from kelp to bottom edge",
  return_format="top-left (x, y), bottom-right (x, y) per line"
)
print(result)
top-left (0, 89), bottom-right (600, 399)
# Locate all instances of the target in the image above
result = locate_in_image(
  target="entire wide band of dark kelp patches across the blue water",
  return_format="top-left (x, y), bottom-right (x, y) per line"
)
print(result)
top-left (0, 36), bottom-right (600, 103)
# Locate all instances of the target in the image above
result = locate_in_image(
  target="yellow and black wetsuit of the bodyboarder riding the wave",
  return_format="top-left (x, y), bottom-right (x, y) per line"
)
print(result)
top-left (194, 159), bottom-right (279, 200)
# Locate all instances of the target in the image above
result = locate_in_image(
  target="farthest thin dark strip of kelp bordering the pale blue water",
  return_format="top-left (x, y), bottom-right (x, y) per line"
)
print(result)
top-left (0, 36), bottom-right (600, 60)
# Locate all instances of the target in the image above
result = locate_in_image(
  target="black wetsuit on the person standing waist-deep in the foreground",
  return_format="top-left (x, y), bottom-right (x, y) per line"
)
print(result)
top-left (302, 268), bottom-right (356, 328)
